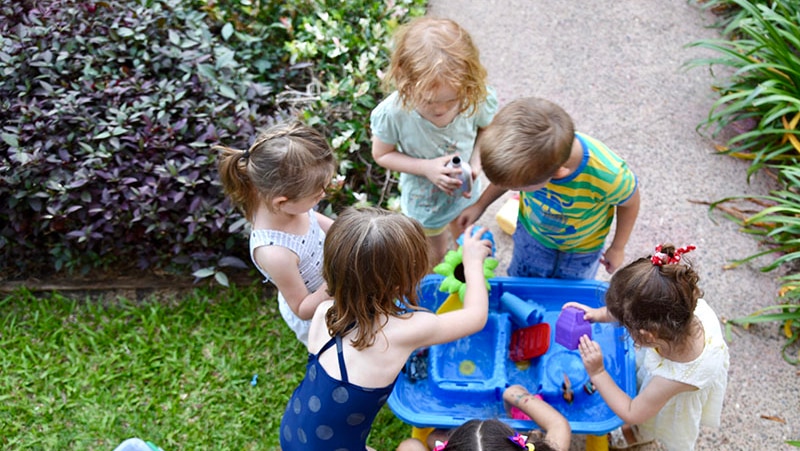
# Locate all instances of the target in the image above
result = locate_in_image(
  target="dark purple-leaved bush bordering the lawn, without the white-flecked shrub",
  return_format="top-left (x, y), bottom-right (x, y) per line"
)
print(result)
top-left (0, 0), bottom-right (279, 277)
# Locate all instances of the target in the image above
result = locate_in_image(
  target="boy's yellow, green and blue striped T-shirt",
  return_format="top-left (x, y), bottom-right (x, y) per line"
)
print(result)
top-left (519, 133), bottom-right (637, 252)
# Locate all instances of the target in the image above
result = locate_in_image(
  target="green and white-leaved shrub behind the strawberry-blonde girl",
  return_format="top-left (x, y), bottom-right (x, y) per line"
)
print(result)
top-left (285, 0), bottom-right (427, 212)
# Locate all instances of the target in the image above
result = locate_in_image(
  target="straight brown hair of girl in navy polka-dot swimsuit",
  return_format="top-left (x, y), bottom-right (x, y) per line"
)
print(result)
top-left (322, 207), bottom-right (428, 349)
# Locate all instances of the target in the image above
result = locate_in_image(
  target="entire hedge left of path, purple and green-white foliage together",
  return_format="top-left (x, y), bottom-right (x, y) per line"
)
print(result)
top-left (0, 0), bottom-right (425, 280)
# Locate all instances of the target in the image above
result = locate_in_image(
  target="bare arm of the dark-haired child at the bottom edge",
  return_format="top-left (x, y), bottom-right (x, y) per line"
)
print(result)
top-left (503, 385), bottom-right (572, 451)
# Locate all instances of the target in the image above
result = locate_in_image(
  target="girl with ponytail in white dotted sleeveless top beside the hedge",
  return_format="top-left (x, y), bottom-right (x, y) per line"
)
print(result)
top-left (218, 122), bottom-right (336, 345)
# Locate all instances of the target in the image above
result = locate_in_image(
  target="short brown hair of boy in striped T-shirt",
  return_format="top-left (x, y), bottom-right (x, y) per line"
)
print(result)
top-left (478, 97), bottom-right (575, 188)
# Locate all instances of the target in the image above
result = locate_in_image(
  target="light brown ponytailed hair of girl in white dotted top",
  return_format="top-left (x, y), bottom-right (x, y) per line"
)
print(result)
top-left (214, 122), bottom-right (336, 222)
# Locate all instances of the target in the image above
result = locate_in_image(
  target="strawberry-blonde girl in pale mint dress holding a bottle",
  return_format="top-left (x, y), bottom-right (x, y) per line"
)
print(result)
top-left (370, 17), bottom-right (497, 265)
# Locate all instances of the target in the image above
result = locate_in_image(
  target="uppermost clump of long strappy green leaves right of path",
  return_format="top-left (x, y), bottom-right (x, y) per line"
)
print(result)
top-left (689, 0), bottom-right (800, 178)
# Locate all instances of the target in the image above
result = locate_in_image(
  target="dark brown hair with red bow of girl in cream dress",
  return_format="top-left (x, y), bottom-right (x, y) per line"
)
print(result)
top-left (606, 244), bottom-right (703, 346)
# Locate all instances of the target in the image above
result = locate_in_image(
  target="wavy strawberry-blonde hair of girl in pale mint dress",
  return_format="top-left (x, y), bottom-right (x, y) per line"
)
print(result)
top-left (383, 17), bottom-right (487, 114)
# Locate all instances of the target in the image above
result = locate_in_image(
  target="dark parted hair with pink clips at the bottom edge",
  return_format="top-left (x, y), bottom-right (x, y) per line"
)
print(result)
top-left (444, 419), bottom-right (556, 451)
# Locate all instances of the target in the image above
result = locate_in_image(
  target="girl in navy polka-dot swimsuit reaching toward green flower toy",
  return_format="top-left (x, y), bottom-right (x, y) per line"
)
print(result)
top-left (280, 208), bottom-right (491, 451)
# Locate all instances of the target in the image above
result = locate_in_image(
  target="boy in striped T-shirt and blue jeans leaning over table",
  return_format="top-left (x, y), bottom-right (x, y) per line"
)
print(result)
top-left (456, 98), bottom-right (639, 279)
